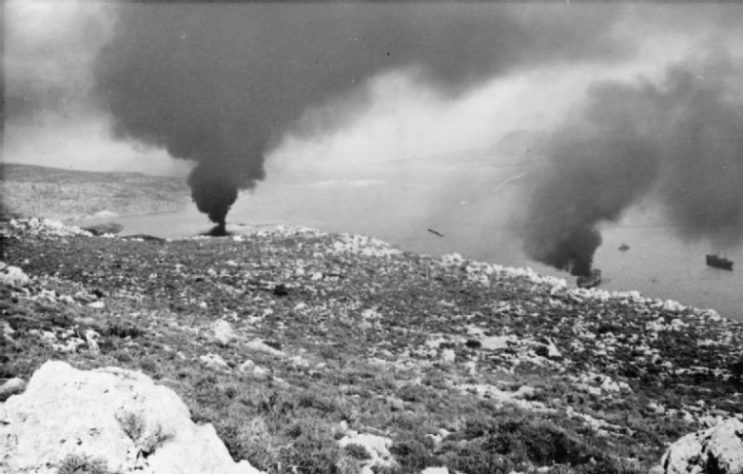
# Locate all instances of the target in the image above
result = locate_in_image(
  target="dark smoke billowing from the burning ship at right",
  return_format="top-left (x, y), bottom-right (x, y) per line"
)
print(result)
top-left (522, 54), bottom-right (743, 275)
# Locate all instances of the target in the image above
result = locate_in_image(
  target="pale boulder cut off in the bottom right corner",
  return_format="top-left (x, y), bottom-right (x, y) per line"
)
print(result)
top-left (661, 418), bottom-right (743, 474)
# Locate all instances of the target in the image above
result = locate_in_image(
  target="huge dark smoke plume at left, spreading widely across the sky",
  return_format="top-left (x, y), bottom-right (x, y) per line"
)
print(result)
top-left (97, 3), bottom-right (626, 224)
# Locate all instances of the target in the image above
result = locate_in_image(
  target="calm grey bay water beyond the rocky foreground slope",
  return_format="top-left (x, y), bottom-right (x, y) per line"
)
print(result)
top-left (77, 182), bottom-right (743, 320)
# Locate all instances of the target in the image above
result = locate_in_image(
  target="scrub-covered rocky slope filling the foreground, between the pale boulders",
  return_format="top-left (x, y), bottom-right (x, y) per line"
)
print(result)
top-left (0, 220), bottom-right (743, 474)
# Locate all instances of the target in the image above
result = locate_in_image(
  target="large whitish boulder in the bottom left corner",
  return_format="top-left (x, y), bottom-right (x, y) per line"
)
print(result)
top-left (0, 361), bottom-right (259, 474)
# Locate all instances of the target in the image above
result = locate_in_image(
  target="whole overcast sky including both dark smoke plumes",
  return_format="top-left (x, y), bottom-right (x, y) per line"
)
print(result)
top-left (3, 0), bottom-right (743, 274)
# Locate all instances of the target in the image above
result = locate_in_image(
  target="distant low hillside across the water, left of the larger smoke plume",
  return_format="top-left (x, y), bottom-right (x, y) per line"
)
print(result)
top-left (0, 163), bottom-right (190, 219)
